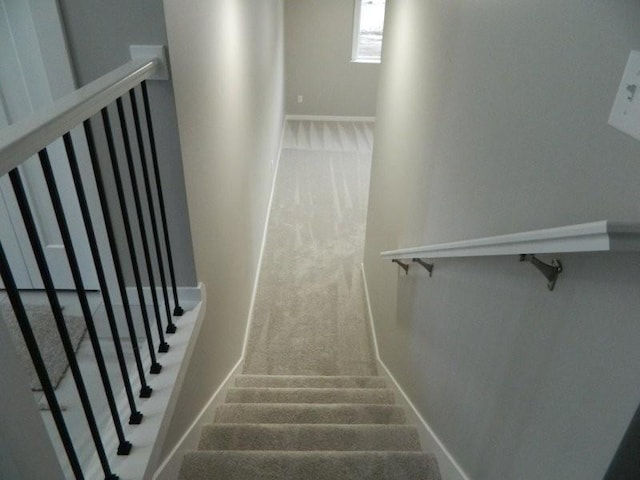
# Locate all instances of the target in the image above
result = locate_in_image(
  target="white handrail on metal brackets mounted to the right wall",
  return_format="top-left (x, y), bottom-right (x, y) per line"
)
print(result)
top-left (380, 220), bottom-right (640, 260)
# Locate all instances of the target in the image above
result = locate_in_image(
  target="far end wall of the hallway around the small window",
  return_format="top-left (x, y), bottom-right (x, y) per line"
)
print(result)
top-left (285, 0), bottom-right (380, 117)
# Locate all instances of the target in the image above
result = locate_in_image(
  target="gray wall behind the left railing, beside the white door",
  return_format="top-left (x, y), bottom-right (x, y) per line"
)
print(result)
top-left (59, 0), bottom-right (196, 286)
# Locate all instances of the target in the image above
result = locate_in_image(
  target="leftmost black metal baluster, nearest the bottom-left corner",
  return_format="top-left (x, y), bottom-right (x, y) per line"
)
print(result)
top-left (0, 244), bottom-right (84, 480)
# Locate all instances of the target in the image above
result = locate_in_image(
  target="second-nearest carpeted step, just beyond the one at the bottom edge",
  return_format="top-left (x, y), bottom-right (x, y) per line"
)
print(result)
top-left (198, 423), bottom-right (420, 451)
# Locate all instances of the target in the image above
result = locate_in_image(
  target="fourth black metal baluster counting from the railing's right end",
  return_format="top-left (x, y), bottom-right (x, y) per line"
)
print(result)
top-left (101, 107), bottom-right (162, 368)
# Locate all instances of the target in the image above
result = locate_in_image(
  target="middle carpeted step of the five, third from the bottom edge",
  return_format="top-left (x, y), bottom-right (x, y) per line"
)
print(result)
top-left (214, 403), bottom-right (405, 424)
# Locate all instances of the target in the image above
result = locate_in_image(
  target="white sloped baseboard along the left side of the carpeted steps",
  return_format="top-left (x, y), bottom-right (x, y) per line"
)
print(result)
top-left (151, 357), bottom-right (243, 480)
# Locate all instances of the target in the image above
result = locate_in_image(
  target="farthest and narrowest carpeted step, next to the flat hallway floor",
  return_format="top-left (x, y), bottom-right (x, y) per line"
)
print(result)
top-left (235, 375), bottom-right (387, 388)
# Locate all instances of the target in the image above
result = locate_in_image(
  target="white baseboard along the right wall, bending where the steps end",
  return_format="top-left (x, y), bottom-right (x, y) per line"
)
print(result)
top-left (362, 264), bottom-right (471, 480)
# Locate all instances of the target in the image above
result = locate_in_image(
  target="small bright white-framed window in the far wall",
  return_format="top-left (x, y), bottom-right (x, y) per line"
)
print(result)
top-left (351, 0), bottom-right (385, 63)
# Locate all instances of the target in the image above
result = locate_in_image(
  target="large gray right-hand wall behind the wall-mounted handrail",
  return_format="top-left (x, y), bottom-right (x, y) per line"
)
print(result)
top-left (365, 0), bottom-right (640, 480)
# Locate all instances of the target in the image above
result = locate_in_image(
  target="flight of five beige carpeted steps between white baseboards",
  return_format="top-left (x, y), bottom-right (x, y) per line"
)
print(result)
top-left (179, 375), bottom-right (440, 480)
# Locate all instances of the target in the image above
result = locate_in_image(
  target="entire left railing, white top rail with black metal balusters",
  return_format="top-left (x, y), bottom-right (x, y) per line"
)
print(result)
top-left (0, 55), bottom-right (183, 479)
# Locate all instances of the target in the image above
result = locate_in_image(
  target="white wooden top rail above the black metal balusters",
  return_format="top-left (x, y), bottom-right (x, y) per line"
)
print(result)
top-left (0, 59), bottom-right (162, 176)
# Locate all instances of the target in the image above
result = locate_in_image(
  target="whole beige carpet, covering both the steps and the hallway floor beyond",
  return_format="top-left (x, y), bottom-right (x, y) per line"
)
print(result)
top-left (180, 121), bottom-right (440, 480)
